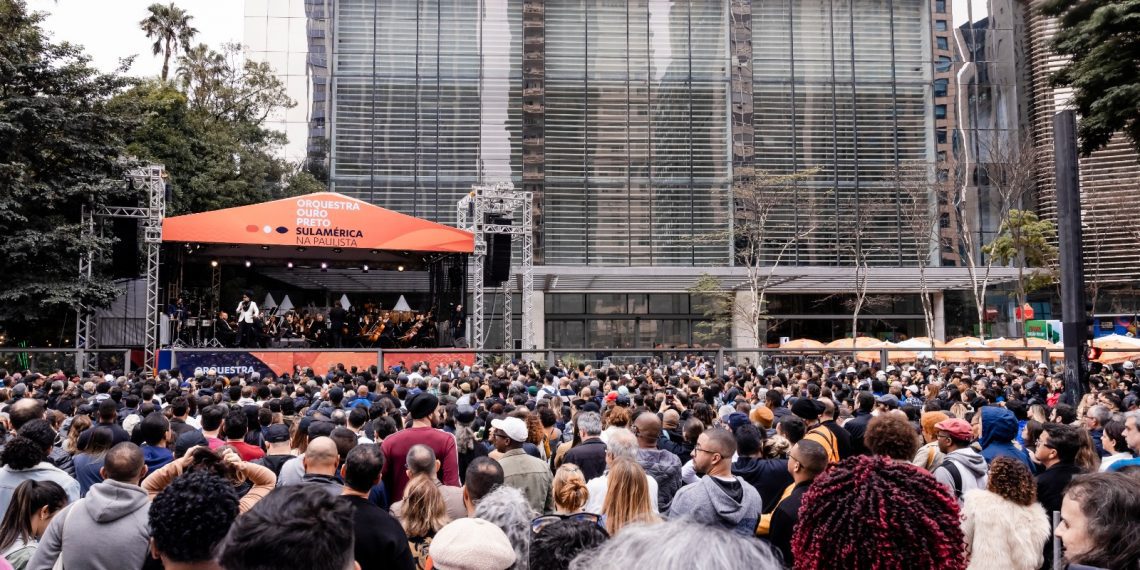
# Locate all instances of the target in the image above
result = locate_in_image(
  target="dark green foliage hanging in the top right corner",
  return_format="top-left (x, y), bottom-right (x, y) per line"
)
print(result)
top-left (1041, 0), bottom-right (1140, 156)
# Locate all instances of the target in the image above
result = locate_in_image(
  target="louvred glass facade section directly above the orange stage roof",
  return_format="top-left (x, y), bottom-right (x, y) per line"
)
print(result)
top-left (331, 0), bottom-right (522, 225)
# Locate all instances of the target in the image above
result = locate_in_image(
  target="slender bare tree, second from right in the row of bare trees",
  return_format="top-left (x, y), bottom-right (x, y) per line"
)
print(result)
top-left (896, 161), bottom-right (951, 339)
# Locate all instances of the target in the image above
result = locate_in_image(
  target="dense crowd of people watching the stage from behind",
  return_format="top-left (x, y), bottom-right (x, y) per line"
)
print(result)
top-left (0, 356), bottom-right (1140, 570)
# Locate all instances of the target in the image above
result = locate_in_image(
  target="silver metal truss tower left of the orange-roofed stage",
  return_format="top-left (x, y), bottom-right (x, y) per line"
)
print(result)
top-left (75, 164), bottom-right (166, 373)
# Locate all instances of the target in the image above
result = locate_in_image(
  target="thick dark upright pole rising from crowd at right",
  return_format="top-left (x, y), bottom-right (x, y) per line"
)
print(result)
top-left (1053, 111), bottom-right (1089, 406)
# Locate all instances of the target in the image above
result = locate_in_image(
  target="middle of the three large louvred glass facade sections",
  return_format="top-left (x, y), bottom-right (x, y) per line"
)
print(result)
top-left (543, 0), bottom-right (731, 266)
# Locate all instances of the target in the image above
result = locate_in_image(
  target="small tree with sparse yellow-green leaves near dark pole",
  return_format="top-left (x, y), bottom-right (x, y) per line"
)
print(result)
top-left (983, 210), bottom-right (1057, 334)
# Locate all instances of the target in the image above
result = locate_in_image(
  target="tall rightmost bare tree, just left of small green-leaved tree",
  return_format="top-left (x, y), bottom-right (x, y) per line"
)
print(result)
top-left (957, 132), bottom-right (1037, 339)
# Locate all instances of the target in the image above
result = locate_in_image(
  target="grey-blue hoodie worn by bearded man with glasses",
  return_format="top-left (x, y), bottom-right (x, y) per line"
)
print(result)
top-left (669, 475), bottom-right (762, 536)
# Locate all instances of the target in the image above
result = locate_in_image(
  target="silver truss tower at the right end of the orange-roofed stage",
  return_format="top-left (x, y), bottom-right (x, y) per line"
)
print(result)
top-left (456, 182), bottom-right (535, 350)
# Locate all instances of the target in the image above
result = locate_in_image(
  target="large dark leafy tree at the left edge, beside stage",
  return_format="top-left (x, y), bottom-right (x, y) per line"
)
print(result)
top-left (0, 0), bottom-right (136, 332)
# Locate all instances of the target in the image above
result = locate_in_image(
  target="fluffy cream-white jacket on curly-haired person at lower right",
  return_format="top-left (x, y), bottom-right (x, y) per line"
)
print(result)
top-left (962, 489), bottom-right (1052, 570)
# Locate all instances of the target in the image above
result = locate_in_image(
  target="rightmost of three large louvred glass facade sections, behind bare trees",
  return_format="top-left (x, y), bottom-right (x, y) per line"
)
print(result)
top-left (752, 0), bottom-right (934, 266)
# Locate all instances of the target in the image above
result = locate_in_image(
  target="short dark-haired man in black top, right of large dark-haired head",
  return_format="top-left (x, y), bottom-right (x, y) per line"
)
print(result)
top-left (341, 443), bottom-right (416, 570)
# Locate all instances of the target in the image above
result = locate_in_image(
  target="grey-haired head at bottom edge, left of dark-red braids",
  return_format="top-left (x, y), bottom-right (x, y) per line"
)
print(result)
top-left (570, 519), bottom-right (782, 570)
